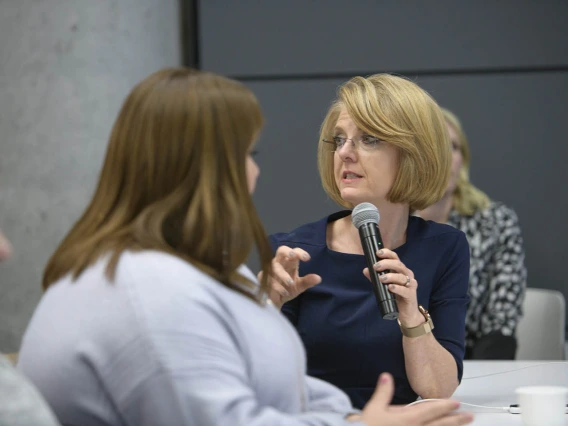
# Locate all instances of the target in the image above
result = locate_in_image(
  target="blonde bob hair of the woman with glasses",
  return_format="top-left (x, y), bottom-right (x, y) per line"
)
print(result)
top-left (318, 74), bottom-right (451, 212)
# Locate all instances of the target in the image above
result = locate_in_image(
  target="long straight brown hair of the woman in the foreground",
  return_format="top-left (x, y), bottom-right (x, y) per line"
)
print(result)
top-left (43, 68), bottom-right (272, 298)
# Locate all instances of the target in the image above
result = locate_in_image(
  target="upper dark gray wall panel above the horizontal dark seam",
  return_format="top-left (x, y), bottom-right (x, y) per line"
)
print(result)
top-left (200, 0), bottom-right (568, 76)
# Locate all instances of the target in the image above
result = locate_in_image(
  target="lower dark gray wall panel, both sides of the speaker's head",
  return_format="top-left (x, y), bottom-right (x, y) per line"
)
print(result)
top-left (248, 73), bottom-right (568, 299)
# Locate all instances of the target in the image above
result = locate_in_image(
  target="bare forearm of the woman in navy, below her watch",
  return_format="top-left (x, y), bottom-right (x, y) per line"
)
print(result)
top-left (402, 333), bottom-right (459, 399)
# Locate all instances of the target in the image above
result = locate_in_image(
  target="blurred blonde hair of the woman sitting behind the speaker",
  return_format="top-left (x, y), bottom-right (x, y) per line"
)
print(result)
top-left (442, 108), bottom-right (489, 216)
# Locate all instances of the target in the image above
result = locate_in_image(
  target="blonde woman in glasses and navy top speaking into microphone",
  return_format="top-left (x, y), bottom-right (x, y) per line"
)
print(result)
top-left (271, 74), bottom-right (469, 407)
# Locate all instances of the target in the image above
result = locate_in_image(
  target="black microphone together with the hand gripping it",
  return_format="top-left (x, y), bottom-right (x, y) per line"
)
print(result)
top-left (351, 203), bottom-right (424, 327)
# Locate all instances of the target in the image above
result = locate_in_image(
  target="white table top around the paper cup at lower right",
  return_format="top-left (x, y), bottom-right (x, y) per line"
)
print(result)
top-left (452, 361), bottom-right (568, 426)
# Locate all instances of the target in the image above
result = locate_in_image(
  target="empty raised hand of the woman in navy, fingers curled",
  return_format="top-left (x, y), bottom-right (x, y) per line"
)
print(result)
top-left (258, 246), bottom-right (321, 309)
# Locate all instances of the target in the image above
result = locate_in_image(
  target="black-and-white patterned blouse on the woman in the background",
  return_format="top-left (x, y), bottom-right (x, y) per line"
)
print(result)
top-left (448, 202), bottom-right (527, 348)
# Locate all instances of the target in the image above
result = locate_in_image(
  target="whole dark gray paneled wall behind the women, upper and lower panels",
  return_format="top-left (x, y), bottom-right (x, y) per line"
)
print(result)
top-left (200, 0), bottom-right (568, 330)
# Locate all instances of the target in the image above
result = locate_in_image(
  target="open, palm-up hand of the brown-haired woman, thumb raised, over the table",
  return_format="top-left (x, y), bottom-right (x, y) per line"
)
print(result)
top-left (358, 373), bottom-right (473, 426)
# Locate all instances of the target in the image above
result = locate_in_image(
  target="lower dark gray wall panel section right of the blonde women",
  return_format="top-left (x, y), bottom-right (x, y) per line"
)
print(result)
top-left (412, 72), bottom-right (568, 300)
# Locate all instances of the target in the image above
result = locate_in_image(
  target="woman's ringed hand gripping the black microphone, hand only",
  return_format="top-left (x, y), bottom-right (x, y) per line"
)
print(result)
top-left (363, 249), bottom-right (424, 328)
